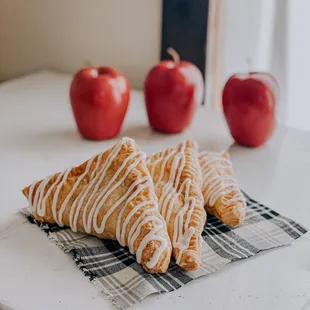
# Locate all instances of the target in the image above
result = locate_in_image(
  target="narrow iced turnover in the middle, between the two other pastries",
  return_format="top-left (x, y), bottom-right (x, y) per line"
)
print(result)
top-left (147, 141), bottom-right (206, 270)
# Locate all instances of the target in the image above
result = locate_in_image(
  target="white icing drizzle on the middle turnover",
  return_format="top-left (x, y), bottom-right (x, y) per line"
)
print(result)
top-left (147, 142), bottom-right (199, 264)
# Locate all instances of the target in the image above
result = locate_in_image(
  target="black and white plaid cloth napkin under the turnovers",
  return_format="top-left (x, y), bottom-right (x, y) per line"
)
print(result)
top-left (23, 195), bottom-right (307, 309)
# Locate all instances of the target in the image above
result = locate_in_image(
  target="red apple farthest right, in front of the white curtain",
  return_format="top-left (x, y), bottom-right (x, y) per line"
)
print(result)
top-left (222, 72), bottom-right (278, 147)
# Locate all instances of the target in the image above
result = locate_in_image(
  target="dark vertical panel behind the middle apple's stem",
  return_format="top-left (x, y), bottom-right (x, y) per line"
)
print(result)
top-left (161, 0), bottom-right (209, 78)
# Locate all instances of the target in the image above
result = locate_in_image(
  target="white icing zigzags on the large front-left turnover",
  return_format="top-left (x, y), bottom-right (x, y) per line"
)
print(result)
top-left (28, 138), bottom-right (168, 269)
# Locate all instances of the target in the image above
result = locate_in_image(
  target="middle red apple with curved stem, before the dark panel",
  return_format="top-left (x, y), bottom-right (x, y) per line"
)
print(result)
top-left (144, 49), bottom-right (204, 133)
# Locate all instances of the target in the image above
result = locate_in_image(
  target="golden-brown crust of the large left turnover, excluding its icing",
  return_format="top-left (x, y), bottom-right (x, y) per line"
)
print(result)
top-left (23, 139), bottom-right (171, 273)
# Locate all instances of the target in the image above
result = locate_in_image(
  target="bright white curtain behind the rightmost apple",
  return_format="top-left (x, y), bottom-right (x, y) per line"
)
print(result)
top-left (222, 0), bottom-right (310, 130)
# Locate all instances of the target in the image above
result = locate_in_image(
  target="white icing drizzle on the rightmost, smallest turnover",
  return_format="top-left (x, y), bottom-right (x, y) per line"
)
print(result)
top-left (199, 152), bottom-right (245, 207)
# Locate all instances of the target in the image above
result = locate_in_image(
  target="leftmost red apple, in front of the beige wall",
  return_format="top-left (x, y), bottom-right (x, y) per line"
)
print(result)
top-left (70, 67), bottom-right (130, 140)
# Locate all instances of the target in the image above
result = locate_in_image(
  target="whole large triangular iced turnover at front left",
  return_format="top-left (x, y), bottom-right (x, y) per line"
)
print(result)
top-left (23, 138), bottom-right (171, 273)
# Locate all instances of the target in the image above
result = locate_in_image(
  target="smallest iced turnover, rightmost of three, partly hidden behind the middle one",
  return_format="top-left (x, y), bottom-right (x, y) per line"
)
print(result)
top-left (199, 152), bottom-right (246, 226)
